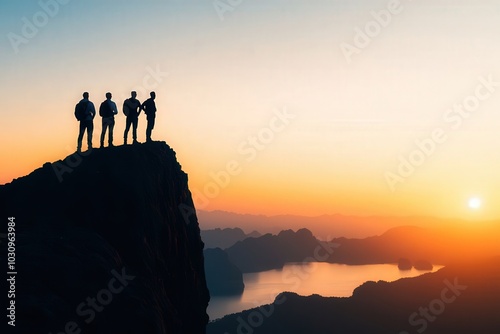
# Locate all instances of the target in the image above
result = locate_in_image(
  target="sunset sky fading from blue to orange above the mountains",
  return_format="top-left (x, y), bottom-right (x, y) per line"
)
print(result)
top-left (0, 0), bottom-right (500, 219)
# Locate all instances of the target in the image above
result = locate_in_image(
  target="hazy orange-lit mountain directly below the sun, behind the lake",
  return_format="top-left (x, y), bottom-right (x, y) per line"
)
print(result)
top-left (328, 226), bottom-right (500, 269)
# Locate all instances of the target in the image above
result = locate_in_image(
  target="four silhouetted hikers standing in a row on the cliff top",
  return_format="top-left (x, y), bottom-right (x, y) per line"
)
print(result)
top-left (75, 91), bottom-right (156, 152)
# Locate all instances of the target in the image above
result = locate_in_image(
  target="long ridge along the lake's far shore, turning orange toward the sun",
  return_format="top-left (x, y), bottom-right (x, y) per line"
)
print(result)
top-left (225, 226), bottom-right (500, 273)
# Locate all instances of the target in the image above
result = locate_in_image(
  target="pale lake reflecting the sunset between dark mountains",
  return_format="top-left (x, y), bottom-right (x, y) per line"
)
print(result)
top-left (207, 262), bottom-right (443, 320)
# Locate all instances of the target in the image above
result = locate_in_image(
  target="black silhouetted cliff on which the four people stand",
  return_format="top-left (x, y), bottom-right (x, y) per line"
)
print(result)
top-left (0, 142), bottom-right (209, 334)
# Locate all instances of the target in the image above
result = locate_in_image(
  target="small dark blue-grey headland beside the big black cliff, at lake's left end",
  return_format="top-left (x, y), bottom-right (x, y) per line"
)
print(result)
top-left (204, 248), bottom-right (245, 296)
